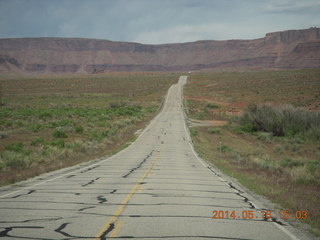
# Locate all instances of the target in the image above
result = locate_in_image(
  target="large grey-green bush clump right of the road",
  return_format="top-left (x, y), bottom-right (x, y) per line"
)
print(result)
top-left (239, 104), bottom-right (320, 141)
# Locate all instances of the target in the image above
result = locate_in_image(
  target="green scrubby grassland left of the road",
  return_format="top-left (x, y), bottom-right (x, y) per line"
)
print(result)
top-left (0, 73), bottom-right (178, 185)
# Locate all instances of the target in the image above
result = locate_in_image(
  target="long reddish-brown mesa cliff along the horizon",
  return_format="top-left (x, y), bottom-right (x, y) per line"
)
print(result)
top-left (0, 28), bottom-right (320, 73)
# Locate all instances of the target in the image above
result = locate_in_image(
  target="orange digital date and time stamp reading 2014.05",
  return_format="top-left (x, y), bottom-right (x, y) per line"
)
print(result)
top-left (212, 210), bottom-right (308, 220)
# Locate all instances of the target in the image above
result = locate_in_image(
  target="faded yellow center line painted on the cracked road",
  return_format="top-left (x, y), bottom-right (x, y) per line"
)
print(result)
top-left (94, 147), bottom-right (158, 239)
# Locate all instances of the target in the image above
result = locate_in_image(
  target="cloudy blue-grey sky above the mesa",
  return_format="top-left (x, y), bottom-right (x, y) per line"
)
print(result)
top-left (0, 0), bottom-right (320, 44)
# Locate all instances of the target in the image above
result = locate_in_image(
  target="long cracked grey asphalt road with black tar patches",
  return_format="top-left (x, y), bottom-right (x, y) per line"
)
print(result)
top-left (0, 76), bottom-right (298, 240)
